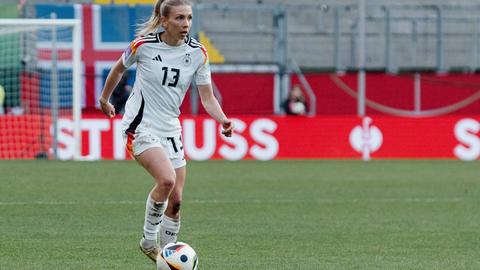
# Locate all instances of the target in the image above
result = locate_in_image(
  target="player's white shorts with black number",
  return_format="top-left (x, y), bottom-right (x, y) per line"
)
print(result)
top-left (123, 132), bottom-right (187, 169)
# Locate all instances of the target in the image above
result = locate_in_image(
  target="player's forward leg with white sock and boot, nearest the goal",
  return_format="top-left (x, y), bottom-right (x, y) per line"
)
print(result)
top-left (136, 147), bottom-right (176, 261)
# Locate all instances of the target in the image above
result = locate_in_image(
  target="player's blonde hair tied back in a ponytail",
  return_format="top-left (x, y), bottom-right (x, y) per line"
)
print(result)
top-left (136, 0), bottom-right (192, 36)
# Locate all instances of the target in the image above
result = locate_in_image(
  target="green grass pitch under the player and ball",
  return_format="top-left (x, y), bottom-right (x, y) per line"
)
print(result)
top-left (0, 160), bottom-right (480, 270)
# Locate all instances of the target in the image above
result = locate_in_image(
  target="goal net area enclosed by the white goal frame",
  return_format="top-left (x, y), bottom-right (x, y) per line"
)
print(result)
top-left (0, 19), bottom-right (81, 159)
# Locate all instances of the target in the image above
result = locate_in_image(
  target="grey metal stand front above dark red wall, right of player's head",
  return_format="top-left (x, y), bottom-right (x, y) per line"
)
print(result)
top-left (190, 1), bottom-right (480, 114)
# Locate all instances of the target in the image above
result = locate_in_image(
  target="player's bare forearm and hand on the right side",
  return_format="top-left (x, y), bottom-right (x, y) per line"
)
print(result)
top-left (197, 84), bottom-right (233, 137)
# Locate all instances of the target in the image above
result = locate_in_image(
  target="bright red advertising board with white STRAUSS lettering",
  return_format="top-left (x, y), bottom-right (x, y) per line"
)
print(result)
top-left (42, 114), bottom-right (480, 160)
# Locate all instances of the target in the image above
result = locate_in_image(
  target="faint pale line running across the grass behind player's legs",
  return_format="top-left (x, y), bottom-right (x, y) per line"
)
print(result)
top-left (0, 197), bottom-right (467, 206)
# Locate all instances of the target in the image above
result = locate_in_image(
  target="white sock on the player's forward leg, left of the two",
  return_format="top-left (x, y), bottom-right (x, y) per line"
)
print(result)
top-left (143, 194), bottom-right (167, 242)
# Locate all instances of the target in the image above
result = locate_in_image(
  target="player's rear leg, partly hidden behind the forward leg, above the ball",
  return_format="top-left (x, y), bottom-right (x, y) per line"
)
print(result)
top-left (159, 166), bottom-right (187, 248)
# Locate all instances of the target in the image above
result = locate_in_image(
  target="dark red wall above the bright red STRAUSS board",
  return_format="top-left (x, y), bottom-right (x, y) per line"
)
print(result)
top-left (182, 73), bottom-right (480, 117)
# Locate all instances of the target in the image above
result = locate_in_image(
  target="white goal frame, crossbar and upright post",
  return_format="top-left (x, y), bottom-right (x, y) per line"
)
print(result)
top-left (0, 19), bottom-right (82, 160)
